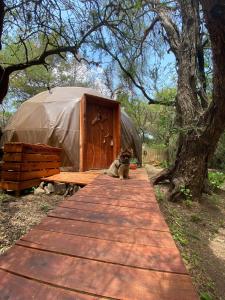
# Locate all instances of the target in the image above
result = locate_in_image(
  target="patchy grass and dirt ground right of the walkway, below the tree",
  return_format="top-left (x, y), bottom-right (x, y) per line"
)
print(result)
top-left (146, 166), bottom-right (225, 300)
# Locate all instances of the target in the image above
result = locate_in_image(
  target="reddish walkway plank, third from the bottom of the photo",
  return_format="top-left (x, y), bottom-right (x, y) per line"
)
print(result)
top-left (17, 230), bottom-right (187, 274)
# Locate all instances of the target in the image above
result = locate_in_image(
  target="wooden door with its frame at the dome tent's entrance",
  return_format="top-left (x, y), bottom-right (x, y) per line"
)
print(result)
top-left (80, 94), bottom-right (120, 171)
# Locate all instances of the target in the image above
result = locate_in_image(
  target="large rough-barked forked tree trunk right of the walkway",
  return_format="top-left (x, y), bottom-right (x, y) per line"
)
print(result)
top-left (153, 0), bottom-right (225, 200)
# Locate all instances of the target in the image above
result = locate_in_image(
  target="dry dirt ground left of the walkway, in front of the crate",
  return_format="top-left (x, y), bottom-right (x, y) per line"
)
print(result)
top-left (0, 193), bottom-right (63, 254)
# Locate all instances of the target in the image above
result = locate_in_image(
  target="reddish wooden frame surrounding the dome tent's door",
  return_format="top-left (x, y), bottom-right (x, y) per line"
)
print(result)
top-left (79, 94), bottom-right (121, 172)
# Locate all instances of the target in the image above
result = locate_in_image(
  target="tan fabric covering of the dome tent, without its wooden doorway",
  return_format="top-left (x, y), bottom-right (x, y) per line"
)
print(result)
top-left (2, 87), bottom-right (141, 168)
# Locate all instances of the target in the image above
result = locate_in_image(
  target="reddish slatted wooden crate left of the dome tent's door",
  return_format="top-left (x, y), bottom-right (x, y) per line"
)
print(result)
top-left (1, 143), bottom-right (62, 191)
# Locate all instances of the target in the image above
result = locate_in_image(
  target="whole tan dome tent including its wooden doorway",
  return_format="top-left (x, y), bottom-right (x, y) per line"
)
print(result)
top-left (1, 87), bottom-right (141, 171)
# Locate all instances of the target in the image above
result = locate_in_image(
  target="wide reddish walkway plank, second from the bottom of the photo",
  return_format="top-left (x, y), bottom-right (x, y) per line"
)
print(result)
top-left (0, 246), bottom-right (195, 300)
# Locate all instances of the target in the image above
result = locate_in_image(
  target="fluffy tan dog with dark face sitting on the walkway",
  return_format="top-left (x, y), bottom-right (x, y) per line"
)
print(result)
top-left (106, 149), bottom-right (132, 180)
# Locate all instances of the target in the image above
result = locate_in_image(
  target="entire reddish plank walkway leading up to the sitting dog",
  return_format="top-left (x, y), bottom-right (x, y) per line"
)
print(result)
top-left (0, 170), bottom-right (198, 300)
